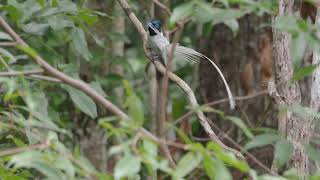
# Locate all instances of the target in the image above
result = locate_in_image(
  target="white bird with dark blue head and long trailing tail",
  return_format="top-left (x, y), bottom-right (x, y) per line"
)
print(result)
top-left (147, 19), bottom-right (236, 109)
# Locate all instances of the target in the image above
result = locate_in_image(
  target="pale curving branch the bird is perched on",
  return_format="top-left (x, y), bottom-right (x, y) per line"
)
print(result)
top-left (118, 0), bottom-right (244, 159)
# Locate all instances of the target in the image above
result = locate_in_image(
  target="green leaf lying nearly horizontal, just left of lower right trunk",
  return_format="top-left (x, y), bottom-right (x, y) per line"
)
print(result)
top-left (244, 134), bottom-right (281, 150)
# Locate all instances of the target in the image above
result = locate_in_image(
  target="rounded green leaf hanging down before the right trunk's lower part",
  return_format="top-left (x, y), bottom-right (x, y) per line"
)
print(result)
top-left (274, 139), bottom-right (293, 168)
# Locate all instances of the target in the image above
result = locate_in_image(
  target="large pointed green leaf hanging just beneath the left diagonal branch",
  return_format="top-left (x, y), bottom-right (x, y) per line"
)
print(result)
top-left (62, 85), bottom-right (97, 118)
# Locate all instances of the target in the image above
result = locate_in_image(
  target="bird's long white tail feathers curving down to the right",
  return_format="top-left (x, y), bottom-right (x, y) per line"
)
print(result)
top-left (166, 44), bottom-right (236, 109)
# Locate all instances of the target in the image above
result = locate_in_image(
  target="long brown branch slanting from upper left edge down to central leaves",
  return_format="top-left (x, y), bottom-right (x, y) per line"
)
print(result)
top-left (0, 16), bottom-right (128, 119)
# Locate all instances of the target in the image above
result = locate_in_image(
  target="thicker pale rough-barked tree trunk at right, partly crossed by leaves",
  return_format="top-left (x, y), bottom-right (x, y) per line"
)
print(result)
top-left (273, 0), bottom-right (312, 176)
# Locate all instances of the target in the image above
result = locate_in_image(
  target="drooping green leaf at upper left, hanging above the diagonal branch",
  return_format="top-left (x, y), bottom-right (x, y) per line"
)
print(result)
top-left (71, 28), bottom-right (92, 61)
